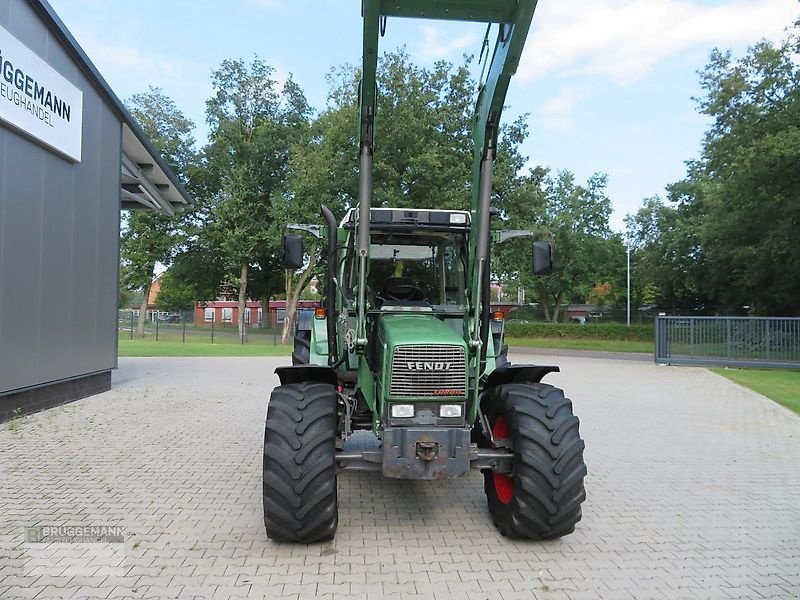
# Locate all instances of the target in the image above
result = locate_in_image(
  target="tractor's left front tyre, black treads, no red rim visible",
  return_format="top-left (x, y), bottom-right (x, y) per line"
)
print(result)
top-left (263, 382), bottom-right (339, 544)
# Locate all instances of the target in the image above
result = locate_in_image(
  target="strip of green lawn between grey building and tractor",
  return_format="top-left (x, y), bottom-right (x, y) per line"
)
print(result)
top-left (118, 336), bottom-right (291, 356)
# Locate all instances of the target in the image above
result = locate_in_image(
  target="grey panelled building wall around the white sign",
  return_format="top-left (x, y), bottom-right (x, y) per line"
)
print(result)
top-left (0, 0), bottom-right (122, 394)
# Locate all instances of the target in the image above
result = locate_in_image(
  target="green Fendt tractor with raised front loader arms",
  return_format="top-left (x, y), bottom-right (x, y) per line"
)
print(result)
top-left (263, 0), bottom-right (586, 543)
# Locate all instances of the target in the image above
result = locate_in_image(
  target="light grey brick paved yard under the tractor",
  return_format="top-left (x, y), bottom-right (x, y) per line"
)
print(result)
top-left (0, 356), bottom-right (800, 600)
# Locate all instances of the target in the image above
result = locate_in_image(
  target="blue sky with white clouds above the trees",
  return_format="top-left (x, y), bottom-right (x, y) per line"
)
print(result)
top-left (49, 0), bottom-right (800, 231)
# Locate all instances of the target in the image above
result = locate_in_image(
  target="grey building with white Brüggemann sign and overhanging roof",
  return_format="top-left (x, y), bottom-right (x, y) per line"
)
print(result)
top-left (0, 0), bottom-right (190, 421)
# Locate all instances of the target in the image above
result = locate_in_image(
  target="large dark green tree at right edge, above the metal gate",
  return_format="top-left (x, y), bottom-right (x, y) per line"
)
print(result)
top-left (669, 21), bottom-right (800, 315)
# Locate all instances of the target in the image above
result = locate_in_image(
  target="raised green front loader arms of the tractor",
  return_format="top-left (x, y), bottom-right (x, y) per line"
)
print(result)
top-left (356, 0), bottom-right (537, 366)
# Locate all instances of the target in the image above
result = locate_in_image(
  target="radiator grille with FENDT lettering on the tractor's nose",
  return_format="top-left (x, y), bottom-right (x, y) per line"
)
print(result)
top-left (390, 346), bottom-right (467, 398)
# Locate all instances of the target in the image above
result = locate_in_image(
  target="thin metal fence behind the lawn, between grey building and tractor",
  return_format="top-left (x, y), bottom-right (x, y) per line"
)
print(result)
top-left (118, 310), bottom-right (283, 346)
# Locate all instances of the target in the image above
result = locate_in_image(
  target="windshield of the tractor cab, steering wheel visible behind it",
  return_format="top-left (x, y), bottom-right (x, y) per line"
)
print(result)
top-left (367, 232), bottom-right (466, 309)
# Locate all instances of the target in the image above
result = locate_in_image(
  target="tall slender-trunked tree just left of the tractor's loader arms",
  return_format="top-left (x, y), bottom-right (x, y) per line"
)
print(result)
top-left (205, 58), bottom-right (311, 338)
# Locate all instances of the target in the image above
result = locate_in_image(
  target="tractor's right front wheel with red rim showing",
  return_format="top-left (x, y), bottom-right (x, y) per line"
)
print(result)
top-left (482, 383), bottom-right (586, 540)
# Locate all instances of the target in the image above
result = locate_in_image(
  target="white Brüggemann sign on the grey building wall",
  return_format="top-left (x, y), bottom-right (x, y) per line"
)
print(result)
top-left (0, 27), bottom-right (83, 162)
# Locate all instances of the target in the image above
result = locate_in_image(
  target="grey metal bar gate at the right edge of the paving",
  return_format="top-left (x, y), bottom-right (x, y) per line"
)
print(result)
top-left (655, 316), bottom-right (800, 369)
